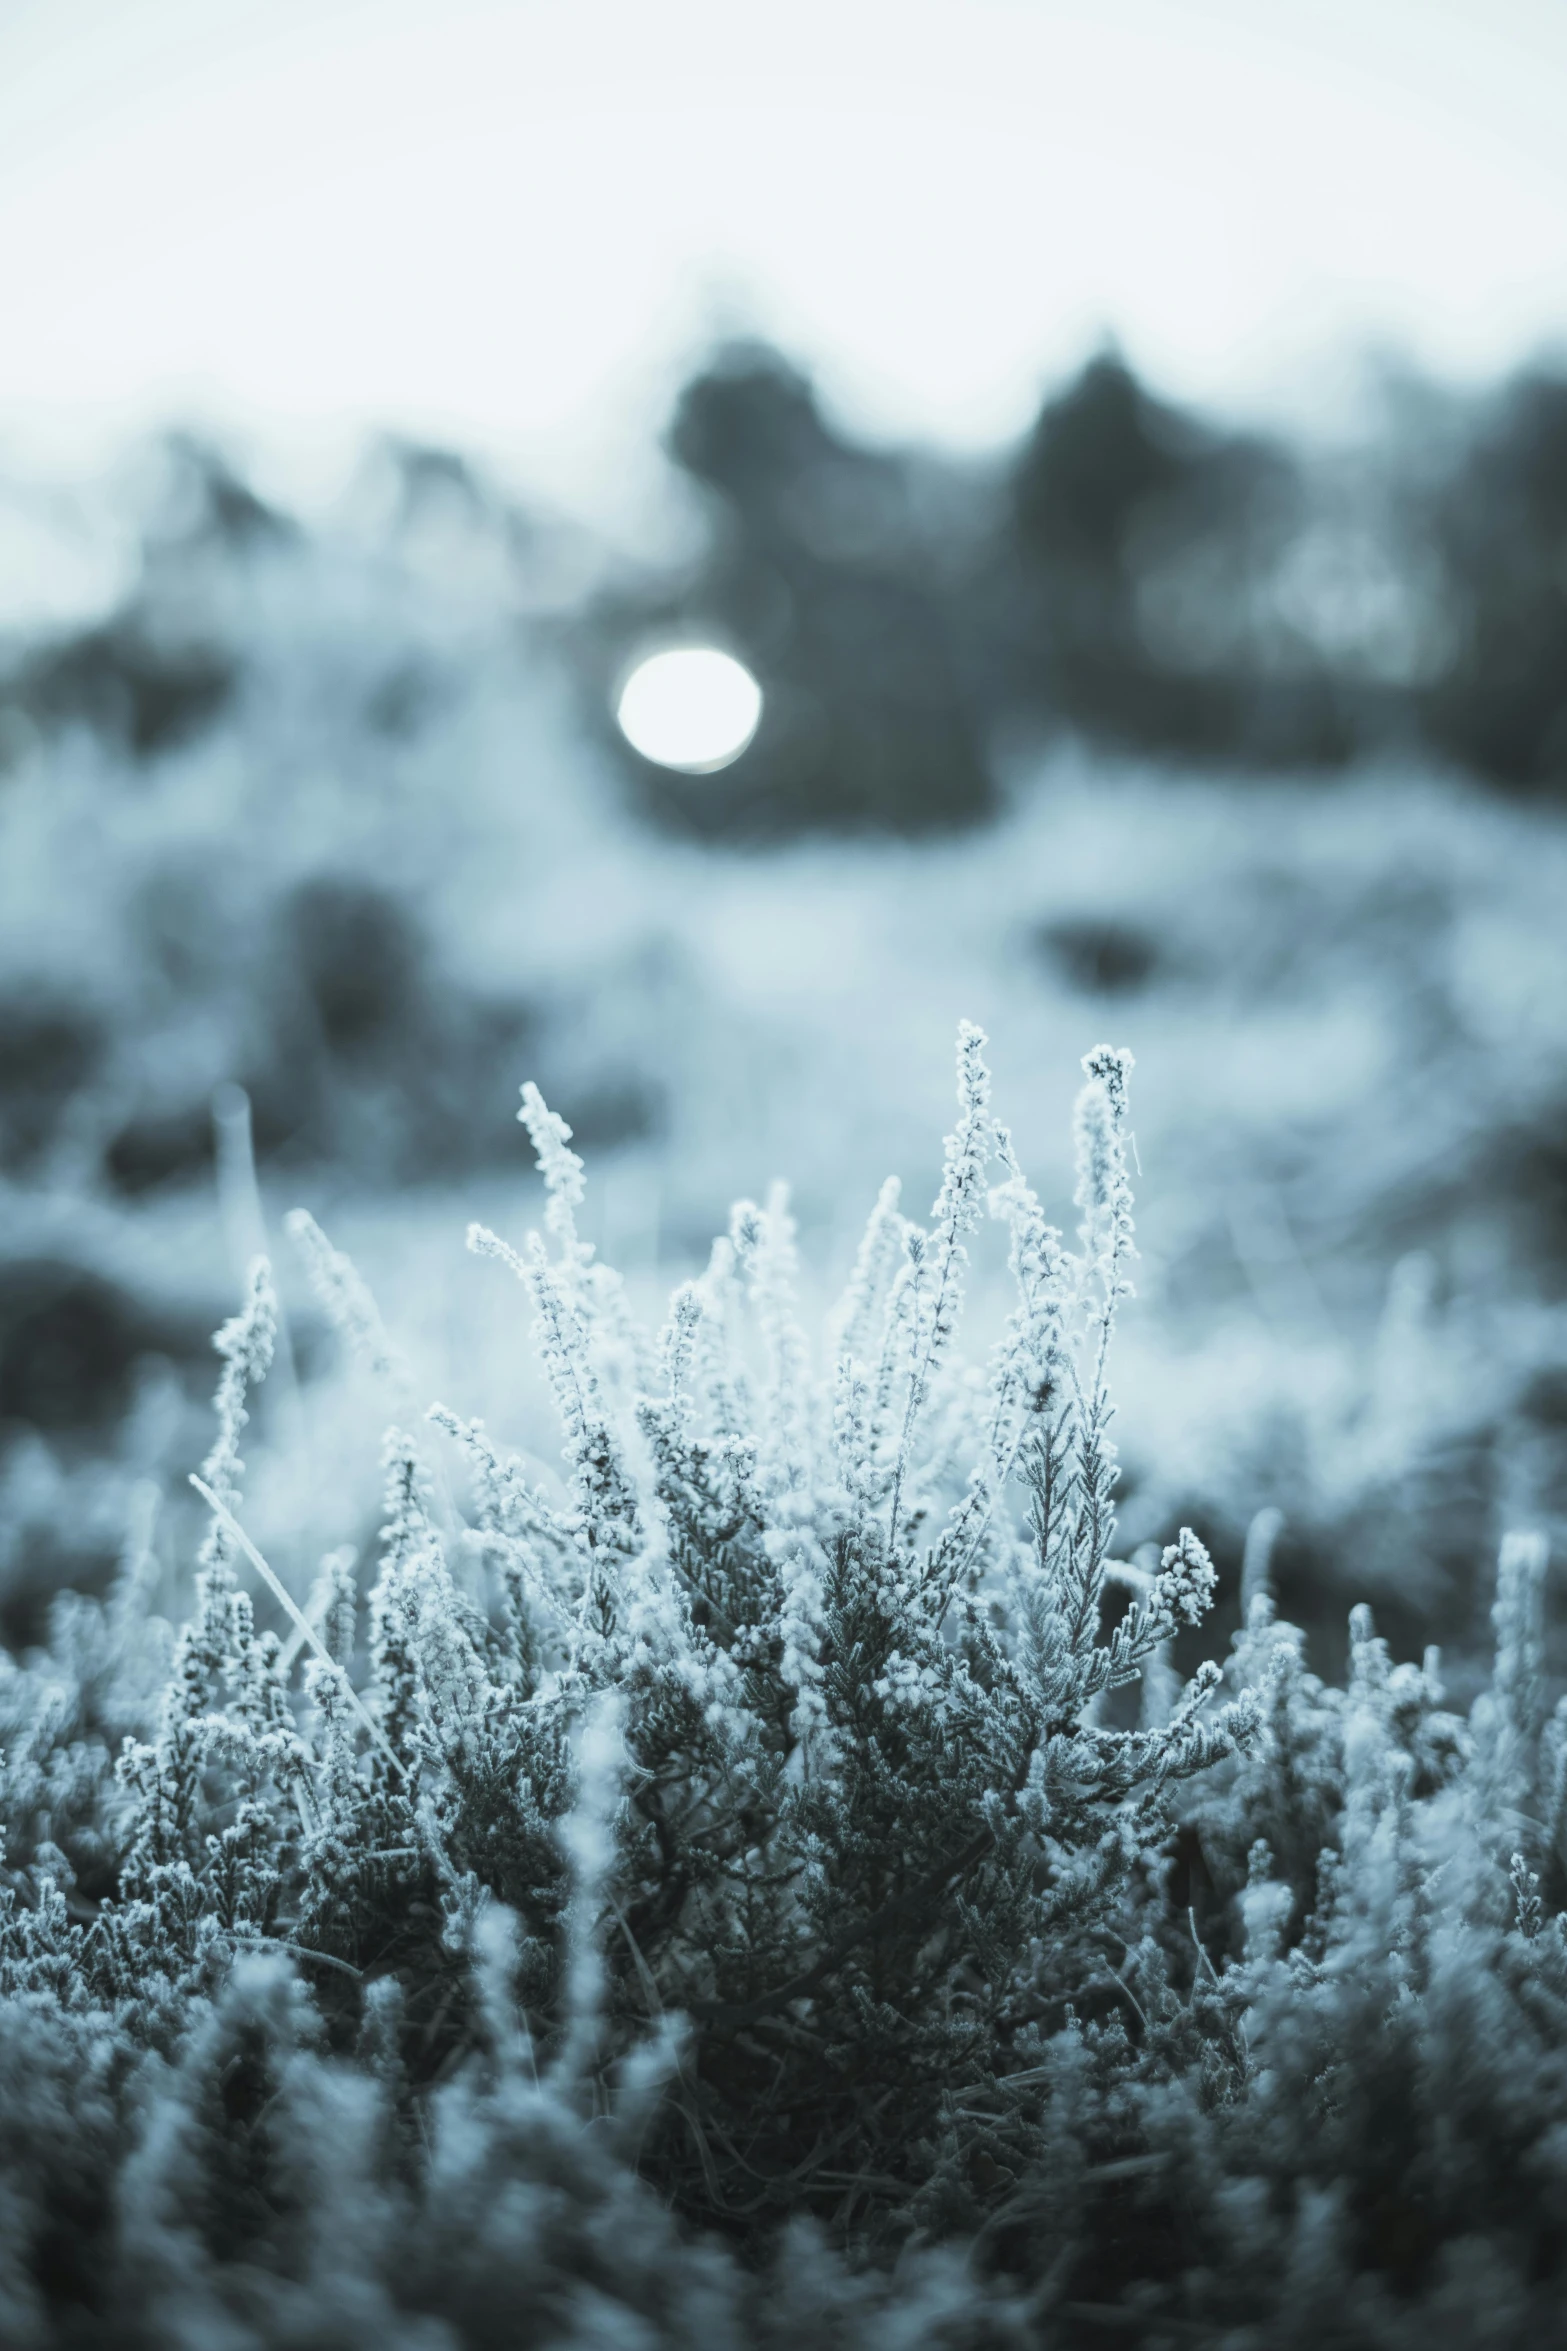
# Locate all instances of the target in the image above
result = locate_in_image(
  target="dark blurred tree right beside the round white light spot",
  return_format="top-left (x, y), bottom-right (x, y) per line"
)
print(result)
top-left (584, 343), bottom-right (996, 837)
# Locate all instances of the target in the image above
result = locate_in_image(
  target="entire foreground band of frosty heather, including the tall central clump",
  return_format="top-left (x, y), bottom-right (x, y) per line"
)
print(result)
top-left (0, 1027), bottom-right (1567, 2351)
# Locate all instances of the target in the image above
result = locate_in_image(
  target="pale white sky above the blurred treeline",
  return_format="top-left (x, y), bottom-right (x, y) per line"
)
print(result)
top-left (0, 0), bottom-right (1567, 503)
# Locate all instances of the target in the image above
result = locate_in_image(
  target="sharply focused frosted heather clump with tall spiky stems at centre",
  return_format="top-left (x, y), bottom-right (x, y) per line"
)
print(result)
top-left (70, 1025), bottom-right (1259, 2212)
